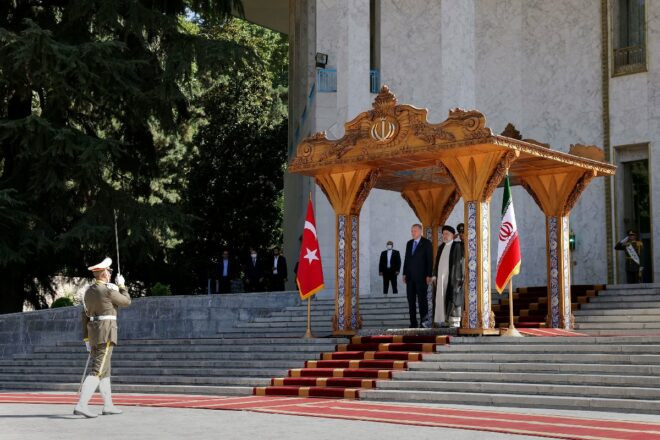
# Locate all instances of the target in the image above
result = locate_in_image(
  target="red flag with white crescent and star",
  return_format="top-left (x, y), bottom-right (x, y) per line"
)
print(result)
top-left (296, 197), bottom-right (323, 299)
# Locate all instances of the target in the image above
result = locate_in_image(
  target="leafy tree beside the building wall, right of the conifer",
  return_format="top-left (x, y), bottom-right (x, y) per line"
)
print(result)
top-left (169, 19), bottom-right (288, 291)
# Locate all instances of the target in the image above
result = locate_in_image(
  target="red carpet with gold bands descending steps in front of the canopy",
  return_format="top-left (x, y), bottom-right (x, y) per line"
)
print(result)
top-left (254, 335), bottom-right (449, 399)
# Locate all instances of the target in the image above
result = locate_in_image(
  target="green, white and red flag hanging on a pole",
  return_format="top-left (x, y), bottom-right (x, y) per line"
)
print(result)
top-left (495, 174), bottom-right (521, 293)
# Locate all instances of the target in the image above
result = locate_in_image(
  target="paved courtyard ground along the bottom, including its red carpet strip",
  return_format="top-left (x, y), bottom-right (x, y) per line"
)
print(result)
top-left (0, 393), bottom-right (660, 440)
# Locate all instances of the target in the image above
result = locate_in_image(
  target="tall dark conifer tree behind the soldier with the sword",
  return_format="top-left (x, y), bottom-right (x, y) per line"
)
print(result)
top-left (0, 0), bottom-right (255, 313)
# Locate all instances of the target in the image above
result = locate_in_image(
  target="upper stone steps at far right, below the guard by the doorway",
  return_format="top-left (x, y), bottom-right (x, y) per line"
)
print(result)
top-left (573, 284), bottom-right (660, 335)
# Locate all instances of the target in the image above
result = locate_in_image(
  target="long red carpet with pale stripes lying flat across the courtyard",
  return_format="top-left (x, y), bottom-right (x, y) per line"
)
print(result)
top-left (0, 393), bottom-right (660, 440)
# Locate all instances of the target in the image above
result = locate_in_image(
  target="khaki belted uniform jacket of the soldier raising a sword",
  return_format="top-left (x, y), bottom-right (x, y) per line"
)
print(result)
top-left (82, 281), bottom-right (131, 346)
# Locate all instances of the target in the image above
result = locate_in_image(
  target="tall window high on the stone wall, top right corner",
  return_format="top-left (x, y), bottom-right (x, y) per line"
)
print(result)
top-left (612, 0), bottom-right (646, 75)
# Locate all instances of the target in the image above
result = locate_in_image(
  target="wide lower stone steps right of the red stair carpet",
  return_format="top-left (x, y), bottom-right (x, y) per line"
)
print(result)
top-left (360, 337), bottom-right (660, 413)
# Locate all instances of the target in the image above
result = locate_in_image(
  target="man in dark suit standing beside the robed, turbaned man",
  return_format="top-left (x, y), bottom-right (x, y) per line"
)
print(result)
top-left (403, 224), bottom-right (433, 328)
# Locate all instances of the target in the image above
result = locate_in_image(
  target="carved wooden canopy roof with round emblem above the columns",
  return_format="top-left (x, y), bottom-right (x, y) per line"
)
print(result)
top-left (289, 85), bottom-right (616, 191)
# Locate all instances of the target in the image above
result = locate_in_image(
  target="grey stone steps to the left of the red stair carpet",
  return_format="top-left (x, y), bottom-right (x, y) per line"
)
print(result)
top-left (0, 295), bottom-right (408, 395)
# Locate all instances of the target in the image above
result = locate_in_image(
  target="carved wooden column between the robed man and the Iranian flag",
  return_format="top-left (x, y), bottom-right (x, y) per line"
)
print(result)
top-left (442, 149), bottom-right (519, 334)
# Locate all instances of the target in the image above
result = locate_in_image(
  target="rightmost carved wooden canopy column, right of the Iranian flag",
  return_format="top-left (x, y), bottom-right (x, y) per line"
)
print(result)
top-left (521, 168), bottom-right (596, 330)
